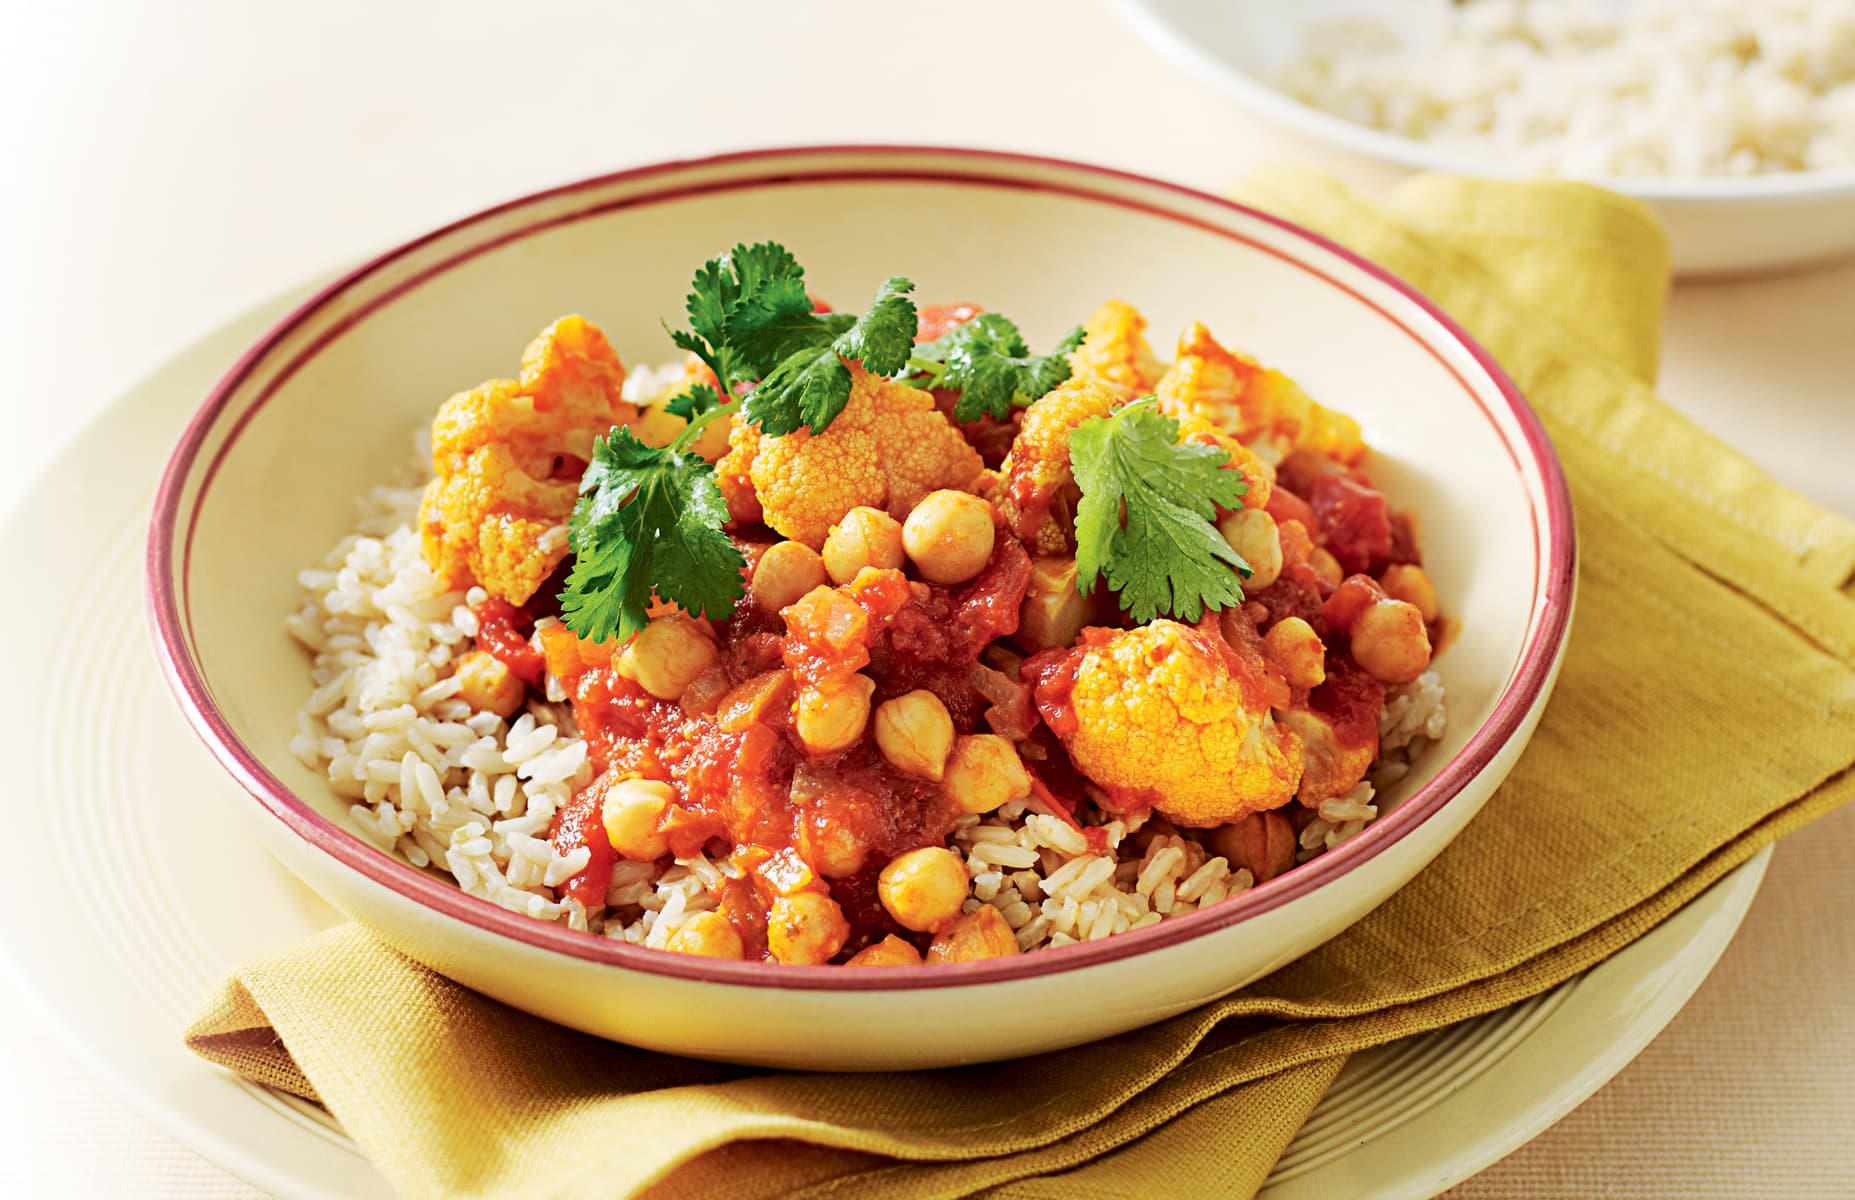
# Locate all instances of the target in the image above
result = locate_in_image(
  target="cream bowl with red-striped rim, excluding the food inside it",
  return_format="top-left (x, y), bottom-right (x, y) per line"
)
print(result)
top-left (147, 147), bottom-right (1575, 1070)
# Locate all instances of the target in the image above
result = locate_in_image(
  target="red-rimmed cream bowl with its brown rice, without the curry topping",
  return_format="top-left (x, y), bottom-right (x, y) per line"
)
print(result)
top-left (148, 147), bottom-right (1575, 1070)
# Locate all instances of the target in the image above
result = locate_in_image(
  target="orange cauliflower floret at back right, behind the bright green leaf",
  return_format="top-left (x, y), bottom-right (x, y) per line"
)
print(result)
top-left (1158, 321), bottom-right (1365, 466)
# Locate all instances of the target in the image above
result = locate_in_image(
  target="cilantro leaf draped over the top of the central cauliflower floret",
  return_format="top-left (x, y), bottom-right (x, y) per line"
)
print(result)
top-left (731, 276), bottom-right (916, 438)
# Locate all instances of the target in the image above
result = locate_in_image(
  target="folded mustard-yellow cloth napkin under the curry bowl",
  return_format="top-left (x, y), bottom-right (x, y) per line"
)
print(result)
top-left (187, 169), bottom-right (1855, 1200)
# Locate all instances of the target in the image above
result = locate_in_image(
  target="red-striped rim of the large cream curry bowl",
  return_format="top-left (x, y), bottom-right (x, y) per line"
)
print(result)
top-left (145, 143), bottom-right (1577, 992)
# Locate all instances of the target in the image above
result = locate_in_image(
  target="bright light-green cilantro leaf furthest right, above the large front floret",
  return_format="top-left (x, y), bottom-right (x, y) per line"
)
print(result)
top-left (1068, 397), bottom-right (1248, 621)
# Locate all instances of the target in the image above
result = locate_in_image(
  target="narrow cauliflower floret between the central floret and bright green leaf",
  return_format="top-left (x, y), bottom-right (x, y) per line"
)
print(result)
top-left (1000, 378), bottom-right (1120, 555)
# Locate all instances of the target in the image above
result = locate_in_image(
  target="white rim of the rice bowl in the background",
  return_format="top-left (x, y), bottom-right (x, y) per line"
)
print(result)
top-left (1109, 0), bottom-right (1855, 206)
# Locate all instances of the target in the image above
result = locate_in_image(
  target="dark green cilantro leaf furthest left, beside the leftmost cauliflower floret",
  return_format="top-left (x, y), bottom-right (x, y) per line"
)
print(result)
top-left (560, 428), bottom-right (748, 642)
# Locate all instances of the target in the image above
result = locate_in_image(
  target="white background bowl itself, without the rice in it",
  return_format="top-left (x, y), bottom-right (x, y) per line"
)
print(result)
top-left (1113, 0), bottom-right (1855, 276)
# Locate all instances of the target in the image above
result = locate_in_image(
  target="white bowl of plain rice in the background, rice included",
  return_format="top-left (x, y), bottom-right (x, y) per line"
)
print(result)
top-left (1115, 0), bottom-right (1855, 274)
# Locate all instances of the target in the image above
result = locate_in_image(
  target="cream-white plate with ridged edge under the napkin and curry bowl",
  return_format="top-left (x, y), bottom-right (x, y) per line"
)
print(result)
top-left (0, 289), bottom-right (1770, 1200)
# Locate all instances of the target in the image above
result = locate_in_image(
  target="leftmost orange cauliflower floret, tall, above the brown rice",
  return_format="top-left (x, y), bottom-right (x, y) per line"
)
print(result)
top-left (419, 317), bottom-right (638, 605)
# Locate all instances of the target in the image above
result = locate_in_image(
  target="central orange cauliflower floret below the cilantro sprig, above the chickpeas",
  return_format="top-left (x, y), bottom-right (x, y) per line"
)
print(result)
top-left (716, 364), bottom-right (985, 549)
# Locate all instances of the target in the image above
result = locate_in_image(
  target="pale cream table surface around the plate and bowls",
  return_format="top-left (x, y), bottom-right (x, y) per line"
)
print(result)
top-left (0, 0), bottom-right (1855, 1198)
